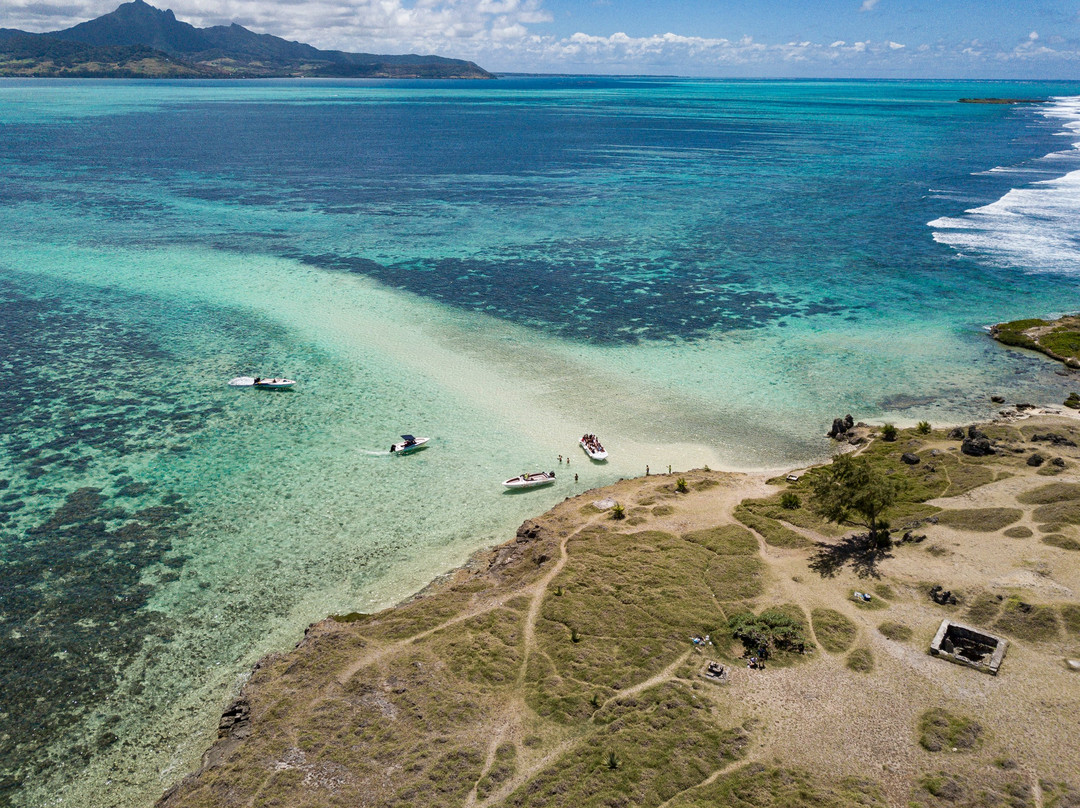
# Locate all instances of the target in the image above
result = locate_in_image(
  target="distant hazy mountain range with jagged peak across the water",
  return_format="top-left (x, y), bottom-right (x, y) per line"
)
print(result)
top-left (0, 0), bottom-right (495, 79)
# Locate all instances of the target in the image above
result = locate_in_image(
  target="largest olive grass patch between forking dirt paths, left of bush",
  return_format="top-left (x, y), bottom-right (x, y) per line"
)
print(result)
top-left (526, 525), bottom-right (766, 723)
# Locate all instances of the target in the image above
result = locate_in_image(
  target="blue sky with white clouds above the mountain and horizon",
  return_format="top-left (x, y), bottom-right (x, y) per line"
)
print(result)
top-left (0, 0), bottom-right (1080, 79)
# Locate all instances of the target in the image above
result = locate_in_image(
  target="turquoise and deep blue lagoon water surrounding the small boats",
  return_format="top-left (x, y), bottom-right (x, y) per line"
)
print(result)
top-left (0, 78), bottom-right (1080, 806)
